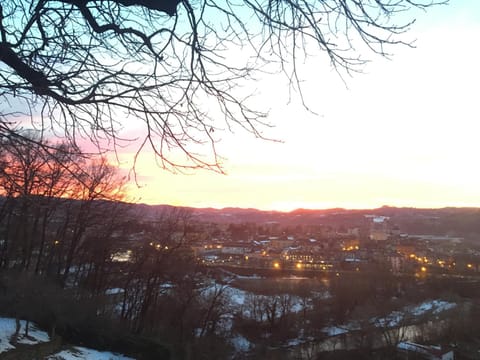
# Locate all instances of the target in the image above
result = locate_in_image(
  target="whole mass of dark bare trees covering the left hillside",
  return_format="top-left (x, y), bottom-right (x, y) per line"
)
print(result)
top-left (0, 137), bottom-right (233, 359)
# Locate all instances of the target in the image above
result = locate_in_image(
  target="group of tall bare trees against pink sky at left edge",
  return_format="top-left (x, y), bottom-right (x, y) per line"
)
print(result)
top-left (0, 133), bottom-right (126, 282)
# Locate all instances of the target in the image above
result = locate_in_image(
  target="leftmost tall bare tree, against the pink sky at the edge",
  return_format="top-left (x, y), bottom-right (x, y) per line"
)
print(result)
top-left (0, 132), bottom-right (82, 272)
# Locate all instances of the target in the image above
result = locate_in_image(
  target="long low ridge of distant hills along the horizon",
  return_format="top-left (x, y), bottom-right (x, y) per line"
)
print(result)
top-left (0, 196), bottom-right (480, 240)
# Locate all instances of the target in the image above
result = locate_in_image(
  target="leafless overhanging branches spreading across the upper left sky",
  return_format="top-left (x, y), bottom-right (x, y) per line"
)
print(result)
top-left (0, 0), bottom-right (442, 169)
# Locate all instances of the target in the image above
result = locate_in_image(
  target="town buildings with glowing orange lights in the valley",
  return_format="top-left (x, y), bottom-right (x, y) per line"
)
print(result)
top-left (188, 215), bottom-right (479, 276)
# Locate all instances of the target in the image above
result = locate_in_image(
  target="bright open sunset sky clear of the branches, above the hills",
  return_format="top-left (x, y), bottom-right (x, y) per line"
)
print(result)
top-left (121, 0), bottom-right (480, 210)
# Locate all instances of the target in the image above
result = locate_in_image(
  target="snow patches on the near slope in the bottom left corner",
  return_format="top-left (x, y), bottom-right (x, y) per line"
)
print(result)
top-left (0, 317), bottom-right (133, 360)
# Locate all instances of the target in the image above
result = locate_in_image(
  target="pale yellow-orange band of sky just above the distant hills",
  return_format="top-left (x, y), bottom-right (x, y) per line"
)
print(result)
top-left (121, 162), bottom-right (480, 212)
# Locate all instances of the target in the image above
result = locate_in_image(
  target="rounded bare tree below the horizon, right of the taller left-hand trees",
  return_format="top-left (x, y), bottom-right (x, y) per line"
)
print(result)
top-left (120, 208), bottom-right (196, 333)
